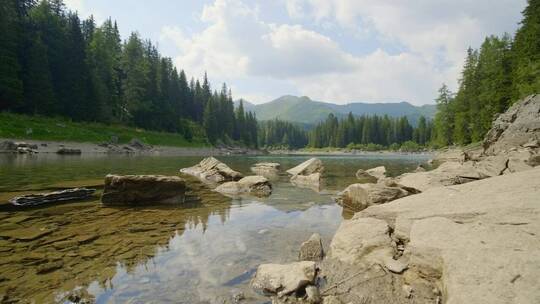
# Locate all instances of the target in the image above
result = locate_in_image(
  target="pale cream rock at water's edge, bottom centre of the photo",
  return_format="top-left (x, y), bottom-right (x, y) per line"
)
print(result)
top-left (251, 261), bottom-right (316, 296)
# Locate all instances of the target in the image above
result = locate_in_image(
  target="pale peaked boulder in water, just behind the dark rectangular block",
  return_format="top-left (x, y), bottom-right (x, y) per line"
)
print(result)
top-left (180, 157), bottom-right (243, 183)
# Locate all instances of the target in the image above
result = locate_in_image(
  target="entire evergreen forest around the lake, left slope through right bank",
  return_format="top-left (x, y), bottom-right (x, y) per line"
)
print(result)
top-left (0, 0), bottom-right (540, 149)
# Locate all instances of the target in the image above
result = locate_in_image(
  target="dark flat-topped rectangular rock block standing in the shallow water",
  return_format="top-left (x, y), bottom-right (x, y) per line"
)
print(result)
top-left (101, 175), bottom-right (186, 205)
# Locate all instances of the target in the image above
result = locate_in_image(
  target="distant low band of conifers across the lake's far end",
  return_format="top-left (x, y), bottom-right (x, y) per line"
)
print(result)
top-left (259, 113), bottom-right (433, 150)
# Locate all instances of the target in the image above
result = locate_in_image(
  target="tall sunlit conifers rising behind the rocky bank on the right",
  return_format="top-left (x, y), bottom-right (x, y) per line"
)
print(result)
top-left (434, 0), bottom-right (540, 146)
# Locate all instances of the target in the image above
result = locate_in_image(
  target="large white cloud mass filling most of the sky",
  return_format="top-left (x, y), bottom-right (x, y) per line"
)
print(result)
top-left (159, 0), bottom-right (525, 104)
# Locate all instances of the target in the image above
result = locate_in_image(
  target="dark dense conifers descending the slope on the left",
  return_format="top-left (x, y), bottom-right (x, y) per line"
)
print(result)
top-left (0, 0), bottom-right (257, 146)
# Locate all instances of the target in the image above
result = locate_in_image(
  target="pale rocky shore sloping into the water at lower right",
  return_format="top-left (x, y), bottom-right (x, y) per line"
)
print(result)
top-left (252, 95), bottom-right (540, 304)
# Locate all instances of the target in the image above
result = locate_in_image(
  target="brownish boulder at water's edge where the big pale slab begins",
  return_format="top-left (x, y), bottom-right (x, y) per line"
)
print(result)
top-left (336, 184), bottom-right (410, 211)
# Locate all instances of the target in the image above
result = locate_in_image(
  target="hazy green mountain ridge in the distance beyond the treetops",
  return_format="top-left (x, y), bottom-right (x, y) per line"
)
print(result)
top-left (238, 95), bottom-right (436, 124)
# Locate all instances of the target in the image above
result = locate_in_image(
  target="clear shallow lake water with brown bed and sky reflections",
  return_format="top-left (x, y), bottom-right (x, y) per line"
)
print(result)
top-left (0, 154), bottom-right (428, 303)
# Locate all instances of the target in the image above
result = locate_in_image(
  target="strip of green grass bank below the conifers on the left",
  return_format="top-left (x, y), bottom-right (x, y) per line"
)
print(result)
top-left (0, 112), bottom-right (209, 147)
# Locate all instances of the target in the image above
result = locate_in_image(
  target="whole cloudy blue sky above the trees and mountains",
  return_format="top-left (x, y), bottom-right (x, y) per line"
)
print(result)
top-left (64, 0), bottom-right (526, 105)
